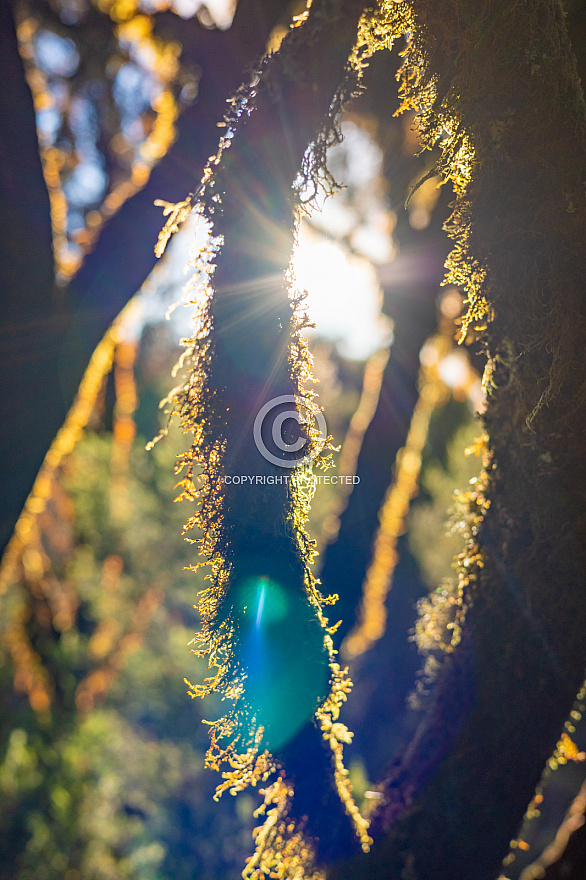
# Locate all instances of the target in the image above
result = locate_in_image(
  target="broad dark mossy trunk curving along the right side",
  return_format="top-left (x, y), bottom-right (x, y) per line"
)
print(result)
top-left (331, 2), bottom-right (586, 880)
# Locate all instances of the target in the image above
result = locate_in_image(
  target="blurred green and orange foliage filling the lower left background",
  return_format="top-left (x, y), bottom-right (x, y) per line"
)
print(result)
top-left (0, 408), bottom-right (252, 880)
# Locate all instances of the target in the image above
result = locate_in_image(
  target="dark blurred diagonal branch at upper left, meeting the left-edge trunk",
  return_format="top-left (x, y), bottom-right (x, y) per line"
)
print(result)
top-left (58, 0), bottom-right (282, 402)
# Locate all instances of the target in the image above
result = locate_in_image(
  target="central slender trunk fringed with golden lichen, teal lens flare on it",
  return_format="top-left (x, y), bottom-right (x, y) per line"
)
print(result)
top-left (152, 2), bottom-right (370, 880)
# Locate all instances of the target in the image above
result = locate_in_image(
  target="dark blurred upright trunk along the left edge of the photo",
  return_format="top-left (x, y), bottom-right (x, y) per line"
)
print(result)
top-left (0, 0), bottom-right (66, 554)
